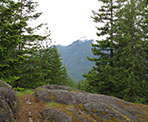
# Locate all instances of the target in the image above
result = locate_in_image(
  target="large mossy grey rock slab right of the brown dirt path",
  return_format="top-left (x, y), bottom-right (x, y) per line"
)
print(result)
top-left (34, 85), bottom-right (148, 122)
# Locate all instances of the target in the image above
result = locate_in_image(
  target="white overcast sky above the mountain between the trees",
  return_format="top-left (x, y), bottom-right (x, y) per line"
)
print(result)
top-left (34, 0), bottom-right (98, 45)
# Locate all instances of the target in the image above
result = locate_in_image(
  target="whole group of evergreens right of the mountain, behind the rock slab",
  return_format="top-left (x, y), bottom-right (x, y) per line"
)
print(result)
top-left (82, 0), bottom-right (148, 103)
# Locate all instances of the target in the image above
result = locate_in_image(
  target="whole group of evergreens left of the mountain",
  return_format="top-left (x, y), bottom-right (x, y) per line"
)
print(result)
top-left (0, 0), bottom-right (72, 90)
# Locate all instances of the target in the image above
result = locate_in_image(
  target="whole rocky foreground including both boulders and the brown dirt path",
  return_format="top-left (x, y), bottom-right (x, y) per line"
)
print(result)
top-left (0, 80), bottom-right (148, 122)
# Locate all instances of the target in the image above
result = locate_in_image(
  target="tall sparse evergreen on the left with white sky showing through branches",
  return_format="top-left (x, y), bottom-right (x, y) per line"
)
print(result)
top-left (13, 0), bottom-right (50, 87)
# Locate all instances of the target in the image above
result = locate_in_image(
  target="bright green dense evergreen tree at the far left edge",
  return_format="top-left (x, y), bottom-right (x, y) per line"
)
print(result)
top-left (0, 0), bottom-right (22, 82)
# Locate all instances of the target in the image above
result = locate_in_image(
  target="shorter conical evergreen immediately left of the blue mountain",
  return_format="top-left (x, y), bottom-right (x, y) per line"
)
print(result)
top-left (40, 46), bottom-right (68, 85)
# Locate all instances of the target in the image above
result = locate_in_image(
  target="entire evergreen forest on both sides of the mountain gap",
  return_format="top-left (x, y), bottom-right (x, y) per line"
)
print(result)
top-left (0, 0), bottom-right (148, 104)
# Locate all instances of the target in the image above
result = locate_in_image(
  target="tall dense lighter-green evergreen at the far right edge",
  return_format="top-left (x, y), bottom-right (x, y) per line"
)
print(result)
top-left (114, 0), bottom-right (148, 103)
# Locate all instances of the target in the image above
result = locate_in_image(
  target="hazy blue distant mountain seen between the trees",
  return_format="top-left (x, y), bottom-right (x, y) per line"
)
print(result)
top-left (57, 39), bottom-right (94, 82)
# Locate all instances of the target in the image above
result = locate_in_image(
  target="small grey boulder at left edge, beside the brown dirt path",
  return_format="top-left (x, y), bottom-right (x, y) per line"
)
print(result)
top-left (0, 80), bottom-right (18, 122)
